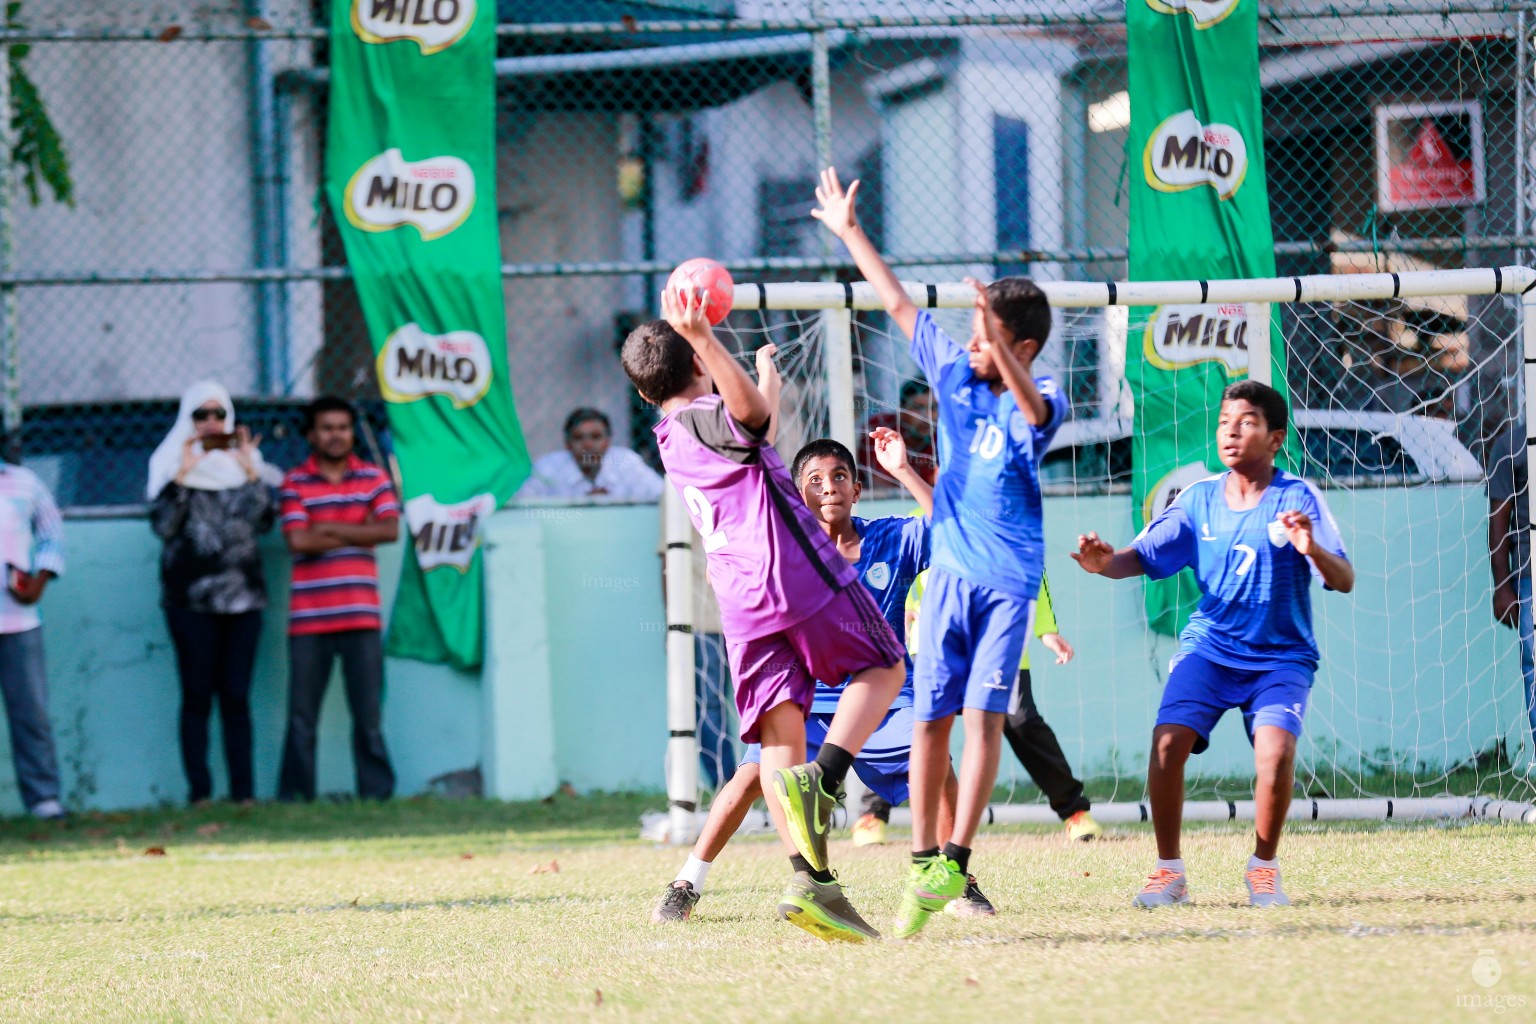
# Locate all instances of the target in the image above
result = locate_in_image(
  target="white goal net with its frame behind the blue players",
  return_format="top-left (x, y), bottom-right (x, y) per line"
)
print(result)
top-left (668, 267), bottom-right (1536, 841)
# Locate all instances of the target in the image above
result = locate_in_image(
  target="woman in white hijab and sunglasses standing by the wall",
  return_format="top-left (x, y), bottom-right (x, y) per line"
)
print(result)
top-left (147, 381), bottom-right (281, 803)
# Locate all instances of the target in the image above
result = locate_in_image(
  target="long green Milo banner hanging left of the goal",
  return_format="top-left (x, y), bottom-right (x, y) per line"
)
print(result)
top-left (326, 0), bottom-right (528, 669)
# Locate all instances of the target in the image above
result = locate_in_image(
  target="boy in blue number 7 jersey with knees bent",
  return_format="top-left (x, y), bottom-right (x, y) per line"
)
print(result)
top-left (1072, 381), bottom-right (1355, 907)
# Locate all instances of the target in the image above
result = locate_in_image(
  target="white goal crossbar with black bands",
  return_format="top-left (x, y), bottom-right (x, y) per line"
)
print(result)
top-left (731, 266), bottom-right (1536, 312)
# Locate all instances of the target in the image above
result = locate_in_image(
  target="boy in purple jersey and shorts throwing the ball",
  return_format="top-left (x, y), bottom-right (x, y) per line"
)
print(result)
top-left (622, 289), bottom-right (905, 941)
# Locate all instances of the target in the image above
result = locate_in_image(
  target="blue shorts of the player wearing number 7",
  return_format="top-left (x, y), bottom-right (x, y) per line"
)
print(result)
top-left (1157, 654), bottom-right (1312, 754)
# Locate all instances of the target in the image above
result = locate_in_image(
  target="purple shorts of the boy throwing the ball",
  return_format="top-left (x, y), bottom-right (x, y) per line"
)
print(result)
top-left (725, 583), bottom-right (906, 743)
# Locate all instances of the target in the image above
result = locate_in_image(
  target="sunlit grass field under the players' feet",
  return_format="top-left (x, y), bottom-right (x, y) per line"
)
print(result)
top-left (0, 797), bottom-right (1536, 1022)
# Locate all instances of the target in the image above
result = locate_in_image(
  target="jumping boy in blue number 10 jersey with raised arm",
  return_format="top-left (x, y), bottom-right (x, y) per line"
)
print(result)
top-left (811, 167), bottom-right (1068, 938)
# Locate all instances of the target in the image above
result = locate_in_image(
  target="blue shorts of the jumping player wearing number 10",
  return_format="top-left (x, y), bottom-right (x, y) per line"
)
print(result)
top-left (912, 570), bottom-right (1035, 722)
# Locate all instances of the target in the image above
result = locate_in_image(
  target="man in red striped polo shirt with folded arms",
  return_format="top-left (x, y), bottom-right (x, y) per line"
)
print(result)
top-left (278, 396), bottom-right (399, 800)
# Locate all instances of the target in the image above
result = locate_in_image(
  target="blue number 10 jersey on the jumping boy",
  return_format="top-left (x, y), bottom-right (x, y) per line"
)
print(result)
top-left (912, 310), bottom-right (1069, 600)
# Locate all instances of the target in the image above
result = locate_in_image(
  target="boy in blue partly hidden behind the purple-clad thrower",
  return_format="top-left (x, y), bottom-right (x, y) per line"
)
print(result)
top-left (651, 427), bottom-right (994, 924)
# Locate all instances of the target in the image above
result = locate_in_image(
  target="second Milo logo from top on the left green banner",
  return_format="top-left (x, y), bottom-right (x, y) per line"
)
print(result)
top-left (344, 149), bottom-right (475, 241)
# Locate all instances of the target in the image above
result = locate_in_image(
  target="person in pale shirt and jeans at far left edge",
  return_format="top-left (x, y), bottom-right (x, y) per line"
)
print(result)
top-left (0, 462), bottom-right (65, 818)
